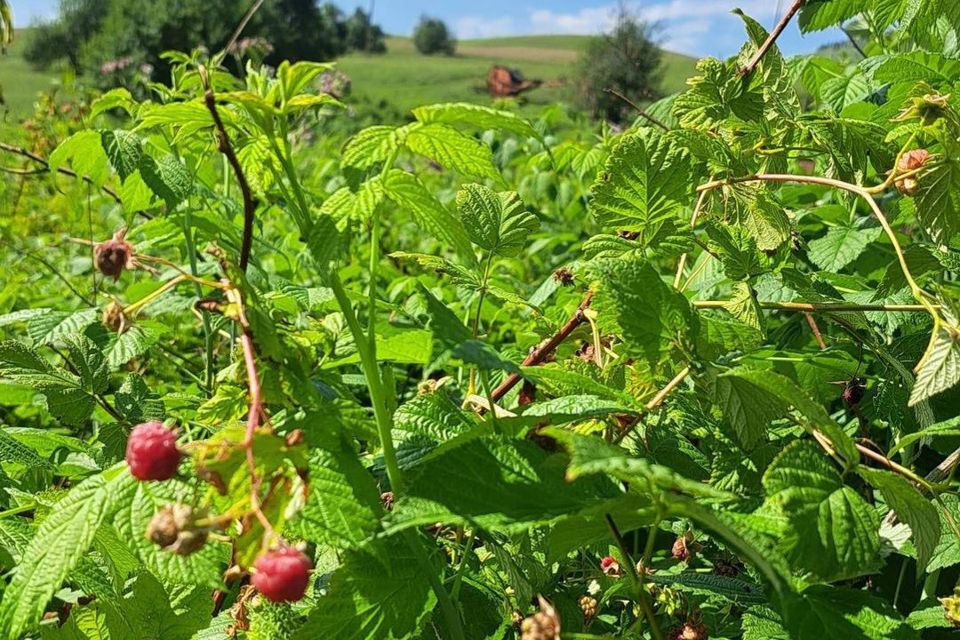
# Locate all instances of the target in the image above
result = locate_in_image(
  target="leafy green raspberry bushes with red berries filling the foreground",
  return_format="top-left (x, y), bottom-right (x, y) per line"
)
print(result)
top-left (0, 0), bottom-right (960, 640)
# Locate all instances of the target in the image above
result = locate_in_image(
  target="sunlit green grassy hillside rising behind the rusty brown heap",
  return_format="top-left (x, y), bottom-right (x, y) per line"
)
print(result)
top-left (338, 36), bottom-right (696, 119)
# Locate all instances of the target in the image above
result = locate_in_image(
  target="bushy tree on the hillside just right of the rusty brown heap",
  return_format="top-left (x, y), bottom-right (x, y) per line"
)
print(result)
top-left (579, 7), bottom-right (662, 123)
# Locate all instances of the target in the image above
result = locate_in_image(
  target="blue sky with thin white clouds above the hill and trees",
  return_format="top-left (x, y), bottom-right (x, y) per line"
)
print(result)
top-left (12, 0), bottom-right (843, 57)
